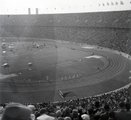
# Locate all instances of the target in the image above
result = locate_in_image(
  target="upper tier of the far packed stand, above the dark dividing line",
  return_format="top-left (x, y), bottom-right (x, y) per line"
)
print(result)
top-left (0, 11), bottom-right (131, 28)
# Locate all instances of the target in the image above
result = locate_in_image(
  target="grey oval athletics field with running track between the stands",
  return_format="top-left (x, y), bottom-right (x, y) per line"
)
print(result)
top-left (0, 38), bottom-right (131, 103)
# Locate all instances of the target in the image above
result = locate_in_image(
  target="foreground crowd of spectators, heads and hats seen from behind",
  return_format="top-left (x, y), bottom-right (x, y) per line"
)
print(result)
top-left (0, 88), bottom-right (131, 120)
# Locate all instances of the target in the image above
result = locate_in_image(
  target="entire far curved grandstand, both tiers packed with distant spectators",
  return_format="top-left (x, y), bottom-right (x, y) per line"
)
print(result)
top-left (0, 10), bottom-right (131, 53)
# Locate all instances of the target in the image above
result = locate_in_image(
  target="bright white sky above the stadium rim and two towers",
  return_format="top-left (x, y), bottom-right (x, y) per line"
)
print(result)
top-left (0, 0), bottom-right (131, 14)
